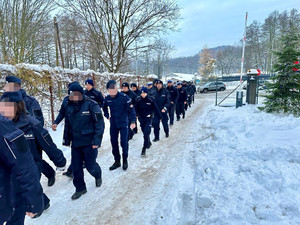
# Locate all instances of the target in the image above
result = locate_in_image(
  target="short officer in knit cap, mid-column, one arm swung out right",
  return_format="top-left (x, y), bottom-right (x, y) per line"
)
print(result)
top-left (136, 87), bottom-right (161, 156)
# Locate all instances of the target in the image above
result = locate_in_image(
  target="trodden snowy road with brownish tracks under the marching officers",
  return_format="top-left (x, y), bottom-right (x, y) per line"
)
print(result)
top-left (26, 95), bottom-right (211, 225)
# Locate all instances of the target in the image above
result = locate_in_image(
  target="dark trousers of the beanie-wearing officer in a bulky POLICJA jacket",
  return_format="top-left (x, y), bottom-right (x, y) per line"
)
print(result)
top-left (72, 145), bottom-right (102, 192)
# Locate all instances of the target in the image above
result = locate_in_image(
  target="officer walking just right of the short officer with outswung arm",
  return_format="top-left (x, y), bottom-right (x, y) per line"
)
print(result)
top-left (153, 80), bottom-right (170, 142)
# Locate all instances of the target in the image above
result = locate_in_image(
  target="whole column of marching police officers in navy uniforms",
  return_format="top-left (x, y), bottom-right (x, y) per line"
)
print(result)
top-left (0, 76), bottom-right (196, 225)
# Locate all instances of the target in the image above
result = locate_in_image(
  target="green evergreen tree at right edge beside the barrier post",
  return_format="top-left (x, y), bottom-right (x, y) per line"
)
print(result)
top-left (262, 28), bottom-right (300, 116)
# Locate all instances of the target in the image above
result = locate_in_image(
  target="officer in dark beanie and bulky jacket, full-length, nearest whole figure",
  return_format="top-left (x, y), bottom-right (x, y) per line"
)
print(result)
top-left (63, 83), bottom-right (104, 200)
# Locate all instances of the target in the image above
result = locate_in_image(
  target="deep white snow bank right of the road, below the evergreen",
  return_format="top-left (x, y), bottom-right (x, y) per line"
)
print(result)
top-left (197, 105), bottom-right (300, 225)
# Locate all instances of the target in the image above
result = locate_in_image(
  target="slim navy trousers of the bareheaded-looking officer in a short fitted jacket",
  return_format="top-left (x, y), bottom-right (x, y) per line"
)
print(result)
top-left (110, 124), bottom-right (128, 162)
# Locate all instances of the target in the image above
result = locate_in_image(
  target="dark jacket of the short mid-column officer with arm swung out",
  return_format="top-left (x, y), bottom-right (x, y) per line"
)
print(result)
top-left (135, 95), bottom-right (161, 119)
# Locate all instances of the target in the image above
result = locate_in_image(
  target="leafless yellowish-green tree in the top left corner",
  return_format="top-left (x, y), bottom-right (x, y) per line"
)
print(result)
top-left (0, 0), bottom-right (55, 63)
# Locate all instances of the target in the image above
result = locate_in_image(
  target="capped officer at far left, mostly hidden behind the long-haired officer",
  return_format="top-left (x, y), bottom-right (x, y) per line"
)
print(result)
top-left (4, 76), bottom-right (55, 186)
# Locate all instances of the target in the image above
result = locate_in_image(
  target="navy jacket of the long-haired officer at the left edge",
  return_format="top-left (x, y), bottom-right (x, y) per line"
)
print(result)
top-left (14, 115), bottom-right (66, 169)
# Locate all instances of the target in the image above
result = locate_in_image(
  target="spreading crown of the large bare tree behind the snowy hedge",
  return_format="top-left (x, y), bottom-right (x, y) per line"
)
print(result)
top-left (62, 0), bottom-right (179, 72)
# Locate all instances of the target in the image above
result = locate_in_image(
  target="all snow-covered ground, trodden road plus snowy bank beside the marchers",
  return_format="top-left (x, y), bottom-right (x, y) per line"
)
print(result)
top-left (25, 93), bottom-right (300, 225)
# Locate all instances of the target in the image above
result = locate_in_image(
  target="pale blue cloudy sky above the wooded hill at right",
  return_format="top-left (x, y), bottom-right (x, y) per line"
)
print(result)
top-left (166, 0), bottom-right (300, 57)
